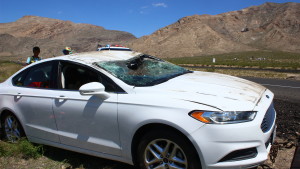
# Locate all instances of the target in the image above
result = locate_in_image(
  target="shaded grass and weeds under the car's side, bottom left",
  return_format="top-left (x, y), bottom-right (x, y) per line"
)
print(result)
top-left (0, 140), bottom-right (134, 169)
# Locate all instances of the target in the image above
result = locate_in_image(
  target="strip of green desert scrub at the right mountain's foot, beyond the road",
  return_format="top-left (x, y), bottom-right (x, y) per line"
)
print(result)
top-left (167, 51), bottom-right (300, 70)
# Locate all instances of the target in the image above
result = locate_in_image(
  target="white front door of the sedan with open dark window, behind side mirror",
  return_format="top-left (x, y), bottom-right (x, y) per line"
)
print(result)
top-left (53, 62), bottom-right (121, 155)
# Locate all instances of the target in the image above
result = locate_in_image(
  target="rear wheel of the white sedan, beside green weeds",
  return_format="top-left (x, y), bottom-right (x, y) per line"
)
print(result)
top-left (1, 113), bottom-right (25, 143)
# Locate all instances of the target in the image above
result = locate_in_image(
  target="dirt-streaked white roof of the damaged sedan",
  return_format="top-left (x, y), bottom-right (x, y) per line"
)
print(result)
top-left (55, 50), bottom-right (142, 64)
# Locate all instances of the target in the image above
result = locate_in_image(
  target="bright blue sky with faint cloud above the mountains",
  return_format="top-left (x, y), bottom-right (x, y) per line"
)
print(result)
top-left (0, 0), bottom-right (300, 37)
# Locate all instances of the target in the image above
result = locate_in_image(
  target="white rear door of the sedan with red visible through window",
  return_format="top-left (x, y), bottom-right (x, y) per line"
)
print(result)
top-left (13, 61), bottom-right (59, 143)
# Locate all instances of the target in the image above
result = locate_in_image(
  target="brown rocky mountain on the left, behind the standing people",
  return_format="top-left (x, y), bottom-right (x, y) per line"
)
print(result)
top-left (0, 16), bottom-right (136, 60)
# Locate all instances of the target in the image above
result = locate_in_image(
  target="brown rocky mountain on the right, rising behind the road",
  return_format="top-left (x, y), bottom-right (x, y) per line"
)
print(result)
top-left (129, 3), bottom-right (300, 57)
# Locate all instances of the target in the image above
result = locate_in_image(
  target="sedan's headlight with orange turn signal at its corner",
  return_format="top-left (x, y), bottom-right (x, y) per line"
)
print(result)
top-left (189, 111), bottom-right (256, 124)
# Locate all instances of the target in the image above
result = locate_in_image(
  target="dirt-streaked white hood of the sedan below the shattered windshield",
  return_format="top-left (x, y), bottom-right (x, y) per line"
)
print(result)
top-left (144, 71), bottom-right (266, 111)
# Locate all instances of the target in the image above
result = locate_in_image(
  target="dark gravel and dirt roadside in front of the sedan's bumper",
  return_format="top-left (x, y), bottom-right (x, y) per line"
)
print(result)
top-left (258, 100), bottom-right (300, 169)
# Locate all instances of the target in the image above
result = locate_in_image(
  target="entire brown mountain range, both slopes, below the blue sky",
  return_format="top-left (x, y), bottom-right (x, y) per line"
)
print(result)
top-left (0, 2), bottom-right (300, 60)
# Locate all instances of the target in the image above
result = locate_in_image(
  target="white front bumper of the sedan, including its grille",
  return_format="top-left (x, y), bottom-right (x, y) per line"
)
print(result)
top-left (191, 90), bottom-right (276, 169)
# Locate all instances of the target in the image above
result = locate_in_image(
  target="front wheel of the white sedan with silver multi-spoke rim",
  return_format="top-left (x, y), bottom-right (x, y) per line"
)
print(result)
top-left (136, 130), bottom-right (201, 169)
